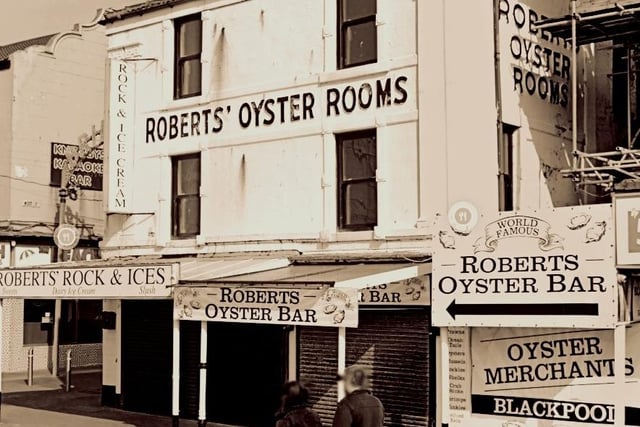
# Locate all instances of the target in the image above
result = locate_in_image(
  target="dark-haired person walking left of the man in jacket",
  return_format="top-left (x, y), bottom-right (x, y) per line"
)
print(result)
top-left (276, 381), bottom-right (322, 427)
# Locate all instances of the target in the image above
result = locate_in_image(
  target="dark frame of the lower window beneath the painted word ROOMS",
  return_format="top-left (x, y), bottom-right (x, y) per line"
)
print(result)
top-left (335, 128), bottom-right (378, 232)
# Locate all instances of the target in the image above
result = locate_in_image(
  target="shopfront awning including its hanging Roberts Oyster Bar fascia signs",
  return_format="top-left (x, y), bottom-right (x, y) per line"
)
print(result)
top-left (174, 263), bottom-right (431, 327)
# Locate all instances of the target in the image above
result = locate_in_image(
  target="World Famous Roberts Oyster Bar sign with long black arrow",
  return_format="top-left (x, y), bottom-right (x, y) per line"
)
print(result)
top-left (432, 205), bottom-right (617, 328)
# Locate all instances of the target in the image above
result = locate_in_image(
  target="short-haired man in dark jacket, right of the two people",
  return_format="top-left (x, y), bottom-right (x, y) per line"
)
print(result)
top-left (333, 365), bottom-right (384, 427)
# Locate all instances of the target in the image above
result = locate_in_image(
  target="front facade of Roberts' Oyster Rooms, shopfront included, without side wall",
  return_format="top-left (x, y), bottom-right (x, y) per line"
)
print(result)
top-left (101, 0), bottom-right (440, 426)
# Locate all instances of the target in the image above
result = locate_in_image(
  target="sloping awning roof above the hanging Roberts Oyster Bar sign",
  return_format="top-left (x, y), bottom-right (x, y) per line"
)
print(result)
top-left (180, 263), bottom-right (431, 289)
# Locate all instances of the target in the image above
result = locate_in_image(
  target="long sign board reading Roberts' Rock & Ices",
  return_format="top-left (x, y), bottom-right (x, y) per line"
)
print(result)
top-left (0, 264), bottom-right (176, 299)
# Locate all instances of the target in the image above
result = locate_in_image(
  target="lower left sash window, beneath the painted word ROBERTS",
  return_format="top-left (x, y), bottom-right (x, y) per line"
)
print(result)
top-left (171, 153), bottom-right (200, 239)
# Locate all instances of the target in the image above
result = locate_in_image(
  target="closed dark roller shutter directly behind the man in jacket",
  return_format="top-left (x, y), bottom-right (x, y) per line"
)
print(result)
top-left (346, 309), bottom-right (429, 427)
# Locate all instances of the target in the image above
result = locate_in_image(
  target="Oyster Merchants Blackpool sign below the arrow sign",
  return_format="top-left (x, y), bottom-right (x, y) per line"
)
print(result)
top-left (470, 327), bottom-right (640, 427)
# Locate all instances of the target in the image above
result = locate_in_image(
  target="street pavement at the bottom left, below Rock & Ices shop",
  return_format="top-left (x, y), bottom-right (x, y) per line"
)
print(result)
top-left (0, 370), bottom-right (199, 427)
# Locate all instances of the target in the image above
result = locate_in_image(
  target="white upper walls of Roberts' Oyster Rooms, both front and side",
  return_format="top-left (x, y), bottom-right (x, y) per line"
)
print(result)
top-left (103, 0), bottom-right (597, 257)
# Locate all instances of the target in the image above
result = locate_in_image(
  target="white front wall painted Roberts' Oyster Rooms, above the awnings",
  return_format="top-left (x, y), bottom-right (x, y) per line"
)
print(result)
top-left (103, 0), bottom-right (427, 256)
